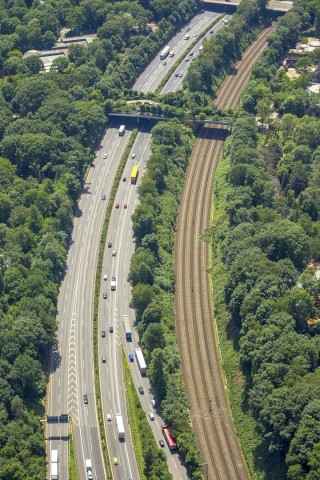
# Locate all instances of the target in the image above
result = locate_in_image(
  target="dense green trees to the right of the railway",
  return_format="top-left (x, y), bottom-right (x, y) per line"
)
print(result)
top-left (214, 2), bottom-right (320, 480)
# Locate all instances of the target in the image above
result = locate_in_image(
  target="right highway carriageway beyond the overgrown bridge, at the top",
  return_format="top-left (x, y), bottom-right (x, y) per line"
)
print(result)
top-left (160, 15), bottom-right (231, 95)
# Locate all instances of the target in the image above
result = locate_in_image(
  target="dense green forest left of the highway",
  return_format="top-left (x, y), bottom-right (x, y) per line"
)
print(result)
top-left (0, 0), bottom-right (198, 480)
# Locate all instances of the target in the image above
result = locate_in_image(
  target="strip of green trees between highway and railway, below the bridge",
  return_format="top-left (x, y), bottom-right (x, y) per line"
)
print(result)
top-left (129, 120), bottom-right (202, 479)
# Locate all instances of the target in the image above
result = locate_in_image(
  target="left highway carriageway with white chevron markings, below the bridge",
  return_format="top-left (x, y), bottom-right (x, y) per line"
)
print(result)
top-left (47, 124), bottom-right (136, 480)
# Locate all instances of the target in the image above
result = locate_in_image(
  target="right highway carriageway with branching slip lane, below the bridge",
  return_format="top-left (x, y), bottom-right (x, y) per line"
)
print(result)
top-left (99, 126), bottom-right (188, 480)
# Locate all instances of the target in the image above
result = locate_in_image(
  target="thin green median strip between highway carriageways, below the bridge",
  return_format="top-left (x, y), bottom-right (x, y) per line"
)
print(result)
top-left (93, 129), bottom-right (139, 480)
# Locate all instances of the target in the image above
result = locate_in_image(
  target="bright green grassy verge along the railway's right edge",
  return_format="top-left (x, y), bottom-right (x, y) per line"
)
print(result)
top-left (211, 150), bottom-right (270, 480)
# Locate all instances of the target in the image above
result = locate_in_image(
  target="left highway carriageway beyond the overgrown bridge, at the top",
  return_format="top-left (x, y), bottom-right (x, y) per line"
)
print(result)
top-left (133, 11), bottom-right (219, 92)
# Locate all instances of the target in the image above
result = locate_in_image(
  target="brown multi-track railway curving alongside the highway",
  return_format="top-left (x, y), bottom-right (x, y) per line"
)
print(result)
top-left (175, 27), bottom-right (273, 480)
